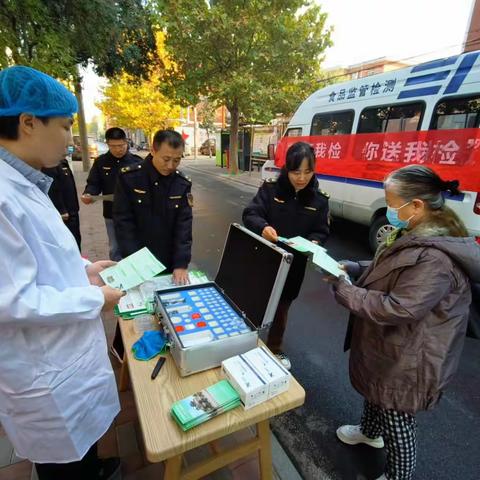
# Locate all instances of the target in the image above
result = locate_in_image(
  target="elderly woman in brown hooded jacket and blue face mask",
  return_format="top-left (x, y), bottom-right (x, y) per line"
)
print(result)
top-left (334, 165), bottom-right (480, 480)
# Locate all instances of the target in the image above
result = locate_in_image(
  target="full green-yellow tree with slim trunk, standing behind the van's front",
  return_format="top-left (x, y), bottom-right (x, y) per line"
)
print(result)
top-left (159, 0), bottom-right (331, 171)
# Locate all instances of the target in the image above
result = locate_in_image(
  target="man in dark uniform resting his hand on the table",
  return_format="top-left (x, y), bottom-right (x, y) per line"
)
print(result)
top-left (111, 130), bottom-right (193, 361)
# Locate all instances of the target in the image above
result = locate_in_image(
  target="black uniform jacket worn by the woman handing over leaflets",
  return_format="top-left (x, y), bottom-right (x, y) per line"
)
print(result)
top-left (243, 172), bottom-right (329, 301)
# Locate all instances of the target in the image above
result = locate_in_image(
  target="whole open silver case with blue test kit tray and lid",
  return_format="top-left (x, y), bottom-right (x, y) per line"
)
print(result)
top-left (155, 224), bottom-right (292, 376)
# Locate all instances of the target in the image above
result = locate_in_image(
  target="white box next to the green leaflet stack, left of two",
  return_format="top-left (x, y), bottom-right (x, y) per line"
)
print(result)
top-left (222, 355), bottom-right (268, 410)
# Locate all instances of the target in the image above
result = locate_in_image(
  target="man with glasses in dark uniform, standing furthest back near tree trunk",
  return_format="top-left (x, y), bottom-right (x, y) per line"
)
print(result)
top-left (81, 127), bottom-right (142, 261)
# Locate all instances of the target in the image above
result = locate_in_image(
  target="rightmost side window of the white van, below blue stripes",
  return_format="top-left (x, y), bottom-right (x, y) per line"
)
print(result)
top-left (430, 95), bottom-right (480, 130)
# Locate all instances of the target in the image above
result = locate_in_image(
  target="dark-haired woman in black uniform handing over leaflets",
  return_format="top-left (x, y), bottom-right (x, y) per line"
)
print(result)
top-left (243, 142), bottom-right (329, 368)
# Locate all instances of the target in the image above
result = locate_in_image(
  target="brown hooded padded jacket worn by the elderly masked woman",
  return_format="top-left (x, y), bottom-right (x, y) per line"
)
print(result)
top-left (335, 225), bottom-right (480, 413)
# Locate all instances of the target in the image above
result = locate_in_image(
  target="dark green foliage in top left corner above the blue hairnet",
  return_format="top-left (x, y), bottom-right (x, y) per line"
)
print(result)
top-left (0, 0), bottom-right (155, 79)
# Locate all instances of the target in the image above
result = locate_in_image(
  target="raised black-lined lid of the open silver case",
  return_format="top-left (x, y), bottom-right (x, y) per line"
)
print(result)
top-left (215, 223), bottom-right (293, 328)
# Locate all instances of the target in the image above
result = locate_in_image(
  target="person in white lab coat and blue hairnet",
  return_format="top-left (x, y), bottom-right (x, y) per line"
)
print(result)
top-left (0, 66), bottom-right (123, 480)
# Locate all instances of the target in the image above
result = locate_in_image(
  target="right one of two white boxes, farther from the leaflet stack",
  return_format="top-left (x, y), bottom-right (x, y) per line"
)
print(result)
top-left (240, 347), bottom-right (291, 398)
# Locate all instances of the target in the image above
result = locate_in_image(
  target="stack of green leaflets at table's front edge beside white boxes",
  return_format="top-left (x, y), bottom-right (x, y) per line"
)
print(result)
top-left (172, 380), bottom-right (241, 432)
